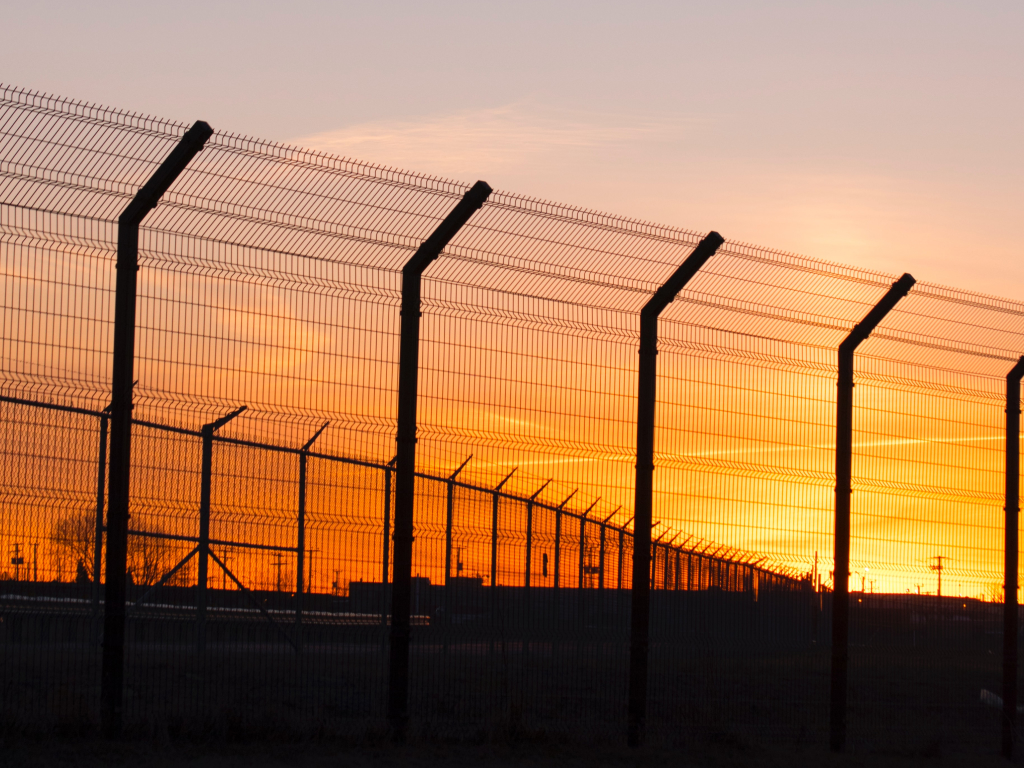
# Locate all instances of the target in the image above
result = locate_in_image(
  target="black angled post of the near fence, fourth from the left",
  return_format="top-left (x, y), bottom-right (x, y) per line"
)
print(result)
top-left (828, 274), bottom-right (914, 752)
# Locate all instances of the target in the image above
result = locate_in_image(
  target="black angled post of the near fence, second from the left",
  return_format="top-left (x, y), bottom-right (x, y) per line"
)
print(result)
top-left (387, 181), bottom-right (490, 739)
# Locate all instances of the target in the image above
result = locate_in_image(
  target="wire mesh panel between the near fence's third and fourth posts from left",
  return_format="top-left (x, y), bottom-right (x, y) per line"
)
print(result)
top-left (630, 246), bottom-right (847, 741)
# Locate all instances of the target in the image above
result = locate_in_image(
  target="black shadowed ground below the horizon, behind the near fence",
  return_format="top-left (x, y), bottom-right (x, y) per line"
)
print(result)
top-left (0, 592), bottom-right (1024, 768)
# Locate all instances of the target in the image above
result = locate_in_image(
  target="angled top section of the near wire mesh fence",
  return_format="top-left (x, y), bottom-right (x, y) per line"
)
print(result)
top-left (0, 86), bottom-right (1024, 373)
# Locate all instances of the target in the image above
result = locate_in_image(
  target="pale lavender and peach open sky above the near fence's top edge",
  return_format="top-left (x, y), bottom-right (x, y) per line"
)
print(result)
top-left (0, 0), bottom-right (1024, 299)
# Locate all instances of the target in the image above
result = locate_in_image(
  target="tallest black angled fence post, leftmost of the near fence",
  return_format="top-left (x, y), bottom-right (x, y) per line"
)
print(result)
top-left (99, 121), bottom-right (213, 738)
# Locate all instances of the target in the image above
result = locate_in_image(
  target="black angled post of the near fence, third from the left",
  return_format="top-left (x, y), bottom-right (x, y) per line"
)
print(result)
top-left (627, 232), bottom-right (725, 746)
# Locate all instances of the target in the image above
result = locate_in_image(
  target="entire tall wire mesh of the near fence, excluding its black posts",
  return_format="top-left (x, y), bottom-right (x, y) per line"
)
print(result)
top-left (0, 83), bottom-right (1024, 751)
